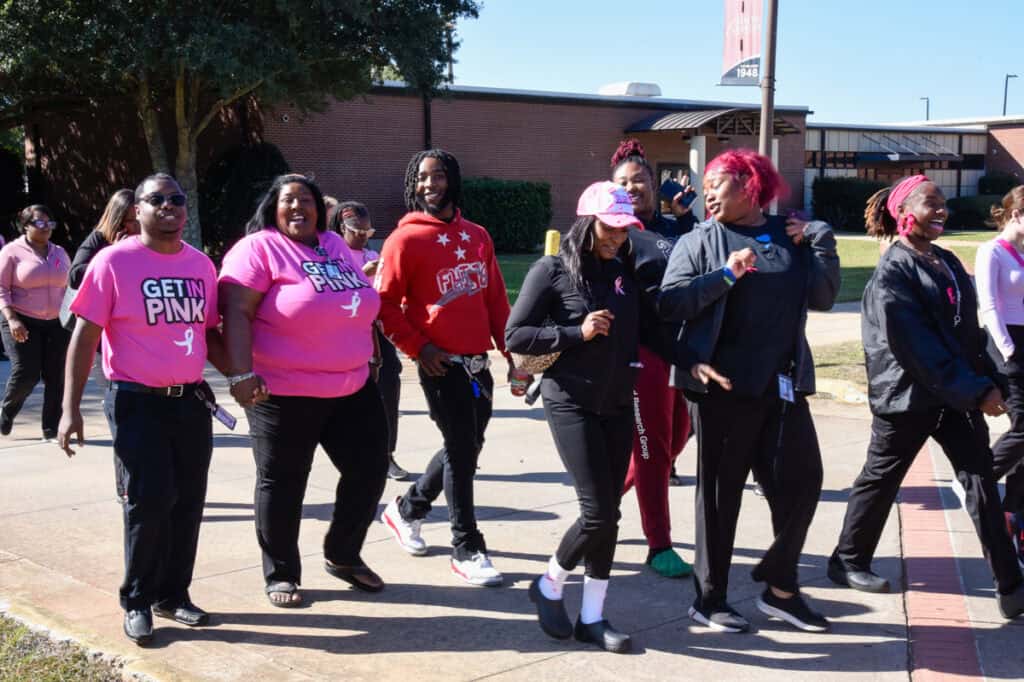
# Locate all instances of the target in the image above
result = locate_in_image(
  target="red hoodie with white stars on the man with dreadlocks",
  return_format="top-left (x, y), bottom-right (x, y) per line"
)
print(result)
top-left (375, 210), bottom-right (509, 357)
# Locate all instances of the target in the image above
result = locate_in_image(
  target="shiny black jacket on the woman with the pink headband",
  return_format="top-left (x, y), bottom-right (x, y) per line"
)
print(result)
top-left (860, 242), bottom-right (996, 415)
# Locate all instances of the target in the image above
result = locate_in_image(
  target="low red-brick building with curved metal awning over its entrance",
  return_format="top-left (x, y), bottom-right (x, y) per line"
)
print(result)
top-left (262, 84), bottom-right (809, 229)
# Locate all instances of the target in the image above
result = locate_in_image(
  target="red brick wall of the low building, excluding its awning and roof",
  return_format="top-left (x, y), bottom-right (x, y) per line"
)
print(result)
top-left (263, 94), bottom-right (805, 237)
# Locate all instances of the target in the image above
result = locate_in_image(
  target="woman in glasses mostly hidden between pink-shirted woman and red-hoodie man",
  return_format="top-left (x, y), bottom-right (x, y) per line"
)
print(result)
top-left (327, 202), bottom-right (409, 480)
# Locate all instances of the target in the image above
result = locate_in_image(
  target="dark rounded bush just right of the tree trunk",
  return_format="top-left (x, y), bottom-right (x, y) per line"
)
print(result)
top-left (199, 143), bottom-right (289, 262)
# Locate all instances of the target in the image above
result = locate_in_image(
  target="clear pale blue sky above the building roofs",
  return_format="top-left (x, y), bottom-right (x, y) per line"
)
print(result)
top-left (455, 0), bottom-right (1024, 123)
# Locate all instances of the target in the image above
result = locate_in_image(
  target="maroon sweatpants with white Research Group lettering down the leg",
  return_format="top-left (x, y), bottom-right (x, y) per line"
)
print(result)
top-left (623, 346), bottom-right (690, 549)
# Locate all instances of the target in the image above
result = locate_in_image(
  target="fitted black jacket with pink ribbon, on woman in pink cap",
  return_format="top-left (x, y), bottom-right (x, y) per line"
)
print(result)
top-left (505, 255), bottom-right (640, 415)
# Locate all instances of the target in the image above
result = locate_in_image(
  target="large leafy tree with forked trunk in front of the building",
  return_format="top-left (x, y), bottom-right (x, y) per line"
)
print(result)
top-left (0, 0), bottom-right (478, 246)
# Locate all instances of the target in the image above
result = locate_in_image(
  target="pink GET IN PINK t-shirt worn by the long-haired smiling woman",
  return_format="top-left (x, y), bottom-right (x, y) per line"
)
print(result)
top-left (220, 227), bottom-right (380, 397)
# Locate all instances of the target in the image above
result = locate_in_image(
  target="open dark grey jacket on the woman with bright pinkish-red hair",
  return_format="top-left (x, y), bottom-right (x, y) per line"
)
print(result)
top-left (657, 216), bottom-right (840, 394)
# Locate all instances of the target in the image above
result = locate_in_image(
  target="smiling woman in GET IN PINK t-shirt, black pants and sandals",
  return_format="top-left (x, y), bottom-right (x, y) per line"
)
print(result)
top-left (219, 175), bottom-right (387, 606)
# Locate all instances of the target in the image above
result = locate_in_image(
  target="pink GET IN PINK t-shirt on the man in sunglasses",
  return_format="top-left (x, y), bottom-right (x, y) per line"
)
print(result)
top-left (71, 237), bottom-right (220, 387)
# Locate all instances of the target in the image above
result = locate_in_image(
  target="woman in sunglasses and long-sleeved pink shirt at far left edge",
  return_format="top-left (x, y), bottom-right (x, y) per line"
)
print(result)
top-left (0, 204), bottom-right (71, 439)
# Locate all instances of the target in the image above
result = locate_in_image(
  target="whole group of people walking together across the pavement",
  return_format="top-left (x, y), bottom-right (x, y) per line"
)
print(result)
top-left (0, 140), bottom-right (1024, 652)
